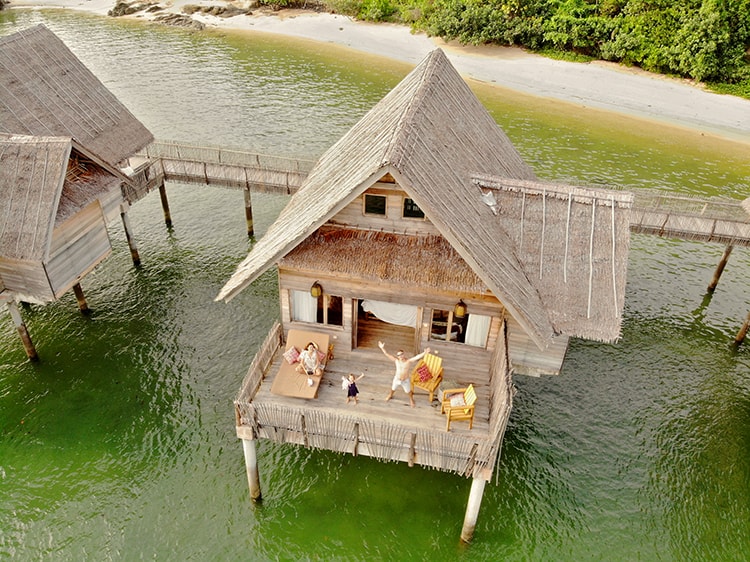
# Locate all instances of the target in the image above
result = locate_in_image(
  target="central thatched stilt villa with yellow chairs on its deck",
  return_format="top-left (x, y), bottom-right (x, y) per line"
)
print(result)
top-left (217, 49), bottom-right (632, 541)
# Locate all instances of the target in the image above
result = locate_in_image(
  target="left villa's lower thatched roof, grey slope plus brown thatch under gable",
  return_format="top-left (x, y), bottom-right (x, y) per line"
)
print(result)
top-left (0, 134), bottom-right (123, 261)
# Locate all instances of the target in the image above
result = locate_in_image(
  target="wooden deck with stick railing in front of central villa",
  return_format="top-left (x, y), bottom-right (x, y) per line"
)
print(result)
top-left (235, 324), bottom-right (512, 472)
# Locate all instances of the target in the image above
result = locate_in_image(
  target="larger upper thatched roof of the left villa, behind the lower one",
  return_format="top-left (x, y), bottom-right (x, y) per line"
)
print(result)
top-left (0, 25), bottom-right (153, 165)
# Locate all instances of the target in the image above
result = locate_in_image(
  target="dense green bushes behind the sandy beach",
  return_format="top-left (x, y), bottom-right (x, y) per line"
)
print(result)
top-left (320, 0), bottom-right (750, 98)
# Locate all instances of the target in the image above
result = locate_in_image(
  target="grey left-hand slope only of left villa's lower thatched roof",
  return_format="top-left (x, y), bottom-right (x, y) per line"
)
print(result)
top-left (0, 136), bottom-right (72, 260)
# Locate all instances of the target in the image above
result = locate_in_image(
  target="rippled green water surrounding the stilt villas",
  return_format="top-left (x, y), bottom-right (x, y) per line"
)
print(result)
top-left (0, 11), bottom-right (750, 561)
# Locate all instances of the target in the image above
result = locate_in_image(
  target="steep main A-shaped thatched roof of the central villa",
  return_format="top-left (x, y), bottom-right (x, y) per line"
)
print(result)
top-left (217, 49), bottom-right (636, 347)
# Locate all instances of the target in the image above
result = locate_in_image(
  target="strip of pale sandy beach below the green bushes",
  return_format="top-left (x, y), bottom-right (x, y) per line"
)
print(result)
top-left (9, 0), bottom-right (750, 142)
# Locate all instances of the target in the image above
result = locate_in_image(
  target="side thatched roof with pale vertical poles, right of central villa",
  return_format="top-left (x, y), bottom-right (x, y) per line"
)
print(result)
top-left (474, 177), bottom-right (633, 342)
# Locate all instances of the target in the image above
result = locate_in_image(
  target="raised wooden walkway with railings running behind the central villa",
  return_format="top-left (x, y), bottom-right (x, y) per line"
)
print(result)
top-left (125, 141), bottom-right (750, 246)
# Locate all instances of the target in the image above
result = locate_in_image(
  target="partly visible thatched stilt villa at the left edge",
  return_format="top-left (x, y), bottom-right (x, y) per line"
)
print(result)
top-left (0, 25), bottom-right (153, 358)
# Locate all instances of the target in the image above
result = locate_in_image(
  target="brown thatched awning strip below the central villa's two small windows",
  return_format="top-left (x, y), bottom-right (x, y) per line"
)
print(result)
top-left (279, 228), bottom-right (488, 294)
